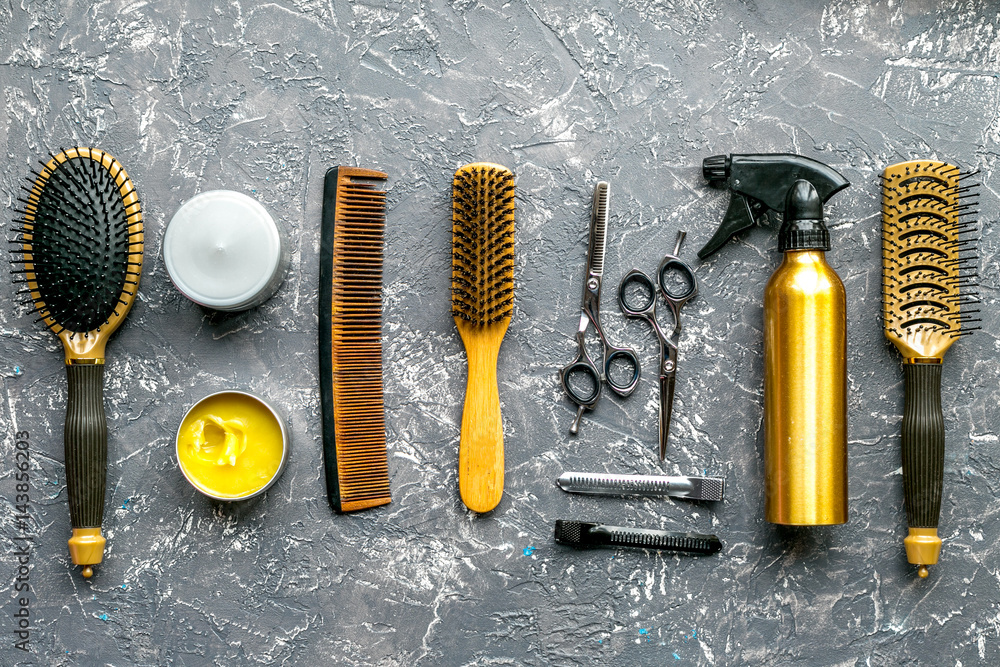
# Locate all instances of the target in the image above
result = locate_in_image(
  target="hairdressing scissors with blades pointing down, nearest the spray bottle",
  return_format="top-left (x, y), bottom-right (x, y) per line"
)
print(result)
top-left (618, 232), bottom-right (698, 461)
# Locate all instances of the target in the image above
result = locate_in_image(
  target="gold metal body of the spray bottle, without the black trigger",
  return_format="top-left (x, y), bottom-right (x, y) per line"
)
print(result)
top-left (764, 247), bottom-right (847, 526)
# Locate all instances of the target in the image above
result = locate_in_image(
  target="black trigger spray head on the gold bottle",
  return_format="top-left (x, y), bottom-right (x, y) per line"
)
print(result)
top-left (698, 153), bottom-right (850, 259)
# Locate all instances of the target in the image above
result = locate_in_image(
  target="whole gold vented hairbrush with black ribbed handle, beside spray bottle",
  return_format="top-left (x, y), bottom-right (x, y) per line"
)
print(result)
top-left (882, 160), bottom-right (979, 577)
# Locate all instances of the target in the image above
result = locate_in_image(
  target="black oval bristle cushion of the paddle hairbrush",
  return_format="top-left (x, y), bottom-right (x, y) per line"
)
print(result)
top-left (16, 157), bottom-right (129, 332)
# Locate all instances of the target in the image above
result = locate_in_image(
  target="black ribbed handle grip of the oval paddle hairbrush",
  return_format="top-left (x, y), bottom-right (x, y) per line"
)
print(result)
top-left (64, 364), bottom-right (108, 528)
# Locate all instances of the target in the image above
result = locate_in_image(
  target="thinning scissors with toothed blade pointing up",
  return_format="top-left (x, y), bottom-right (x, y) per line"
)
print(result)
top-left (559, 181), bottom-right (639, 435)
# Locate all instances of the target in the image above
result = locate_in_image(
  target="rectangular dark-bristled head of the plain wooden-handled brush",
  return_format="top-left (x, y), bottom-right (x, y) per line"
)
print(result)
top-left (452, 164), bottom-right (514, 326)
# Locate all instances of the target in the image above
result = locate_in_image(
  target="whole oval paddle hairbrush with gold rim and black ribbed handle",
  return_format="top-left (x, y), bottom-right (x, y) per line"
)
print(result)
top-left (11, 148), bottom-right (143, 577)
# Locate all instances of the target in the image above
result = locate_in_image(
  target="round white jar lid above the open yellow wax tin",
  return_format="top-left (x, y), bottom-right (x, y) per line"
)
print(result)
top-left (163, 190), bottom-right (287, 310)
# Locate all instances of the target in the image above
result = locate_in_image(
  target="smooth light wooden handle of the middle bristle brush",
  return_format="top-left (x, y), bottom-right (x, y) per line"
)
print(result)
top-left (458, 320), bottom-right (509, 512)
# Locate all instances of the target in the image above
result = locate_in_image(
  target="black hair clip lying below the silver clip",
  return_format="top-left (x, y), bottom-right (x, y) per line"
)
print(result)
top-left (556, 519), bottom-right (722, 556)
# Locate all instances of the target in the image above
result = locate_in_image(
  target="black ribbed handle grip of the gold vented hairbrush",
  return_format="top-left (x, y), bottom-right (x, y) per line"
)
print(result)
top-left (903, 363), bottom-right (944, 528)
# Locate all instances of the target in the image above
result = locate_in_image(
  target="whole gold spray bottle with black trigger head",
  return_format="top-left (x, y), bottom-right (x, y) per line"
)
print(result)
top-left (698, 154), bottom-right (850, 526)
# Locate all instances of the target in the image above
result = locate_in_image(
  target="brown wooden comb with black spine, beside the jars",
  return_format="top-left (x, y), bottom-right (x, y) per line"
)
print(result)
top-left (319, 167), bottom-right (392, 512)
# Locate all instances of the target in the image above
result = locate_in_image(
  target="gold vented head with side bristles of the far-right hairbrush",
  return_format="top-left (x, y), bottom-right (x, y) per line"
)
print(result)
top-left (882, 160), bottom-right (979, 360)
